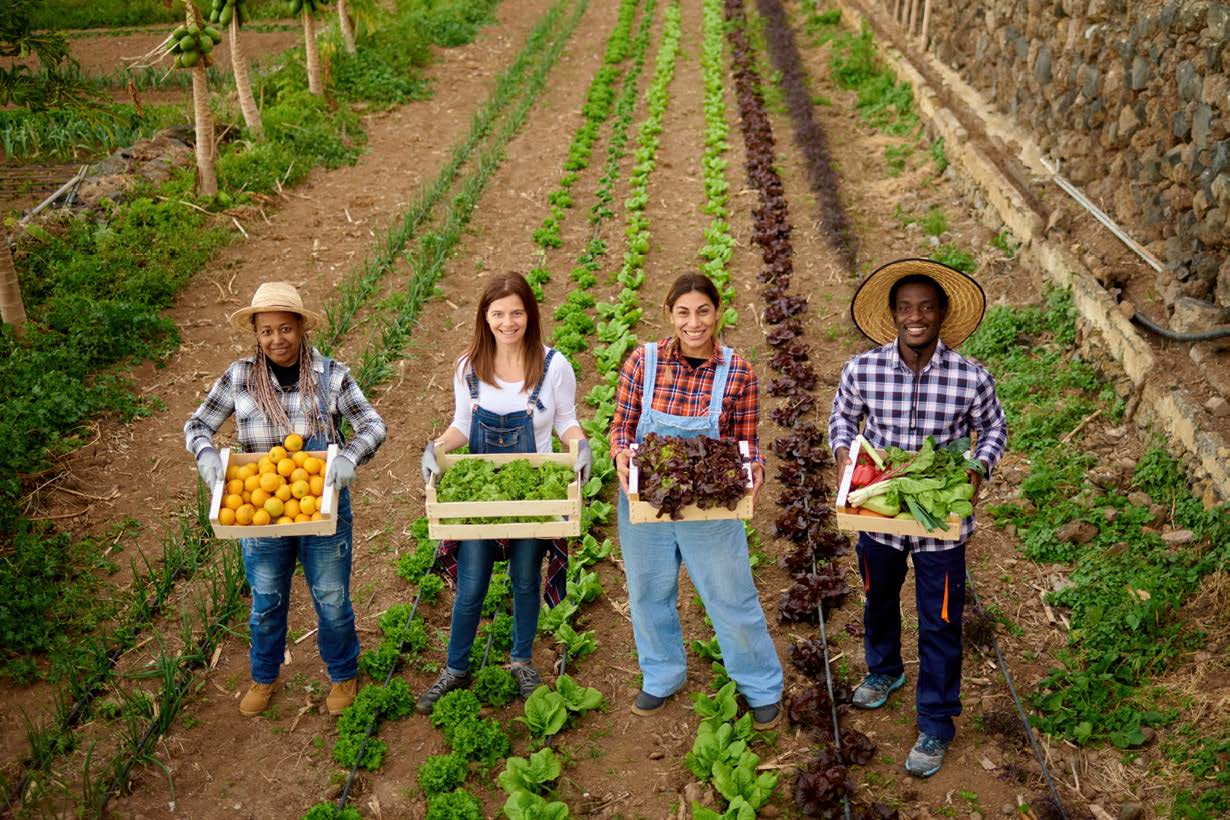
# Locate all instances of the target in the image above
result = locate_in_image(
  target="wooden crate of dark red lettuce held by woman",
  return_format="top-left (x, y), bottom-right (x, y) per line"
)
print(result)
top-left (627, 433), bottom-right (753, 524)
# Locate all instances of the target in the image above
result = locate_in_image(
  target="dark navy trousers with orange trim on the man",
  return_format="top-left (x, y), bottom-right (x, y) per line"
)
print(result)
top-left (857, 534), bottom-right (966, 741)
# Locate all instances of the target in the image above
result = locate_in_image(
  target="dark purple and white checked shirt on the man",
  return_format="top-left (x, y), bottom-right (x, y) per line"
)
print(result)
top-left (829, 339), bottom-right (1007, 552)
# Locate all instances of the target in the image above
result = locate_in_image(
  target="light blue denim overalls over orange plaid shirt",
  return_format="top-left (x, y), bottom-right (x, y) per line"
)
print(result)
top-left (619, 343), bottom-right (782, 707)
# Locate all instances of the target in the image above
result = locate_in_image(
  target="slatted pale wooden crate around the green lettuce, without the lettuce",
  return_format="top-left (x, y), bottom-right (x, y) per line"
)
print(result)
top-left (427, 441), bottom-right (582, 541)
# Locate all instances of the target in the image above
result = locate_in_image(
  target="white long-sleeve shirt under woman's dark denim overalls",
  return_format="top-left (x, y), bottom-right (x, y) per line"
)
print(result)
top-left (450, 352), bottom-right (577, 452)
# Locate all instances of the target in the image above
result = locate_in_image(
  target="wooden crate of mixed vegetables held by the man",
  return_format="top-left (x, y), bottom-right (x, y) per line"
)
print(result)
top-left (836, 435), bottom-right (983, 541)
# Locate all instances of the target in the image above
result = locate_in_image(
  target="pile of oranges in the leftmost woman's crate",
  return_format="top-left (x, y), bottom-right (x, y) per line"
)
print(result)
top-left (218, 433), bottom-right (325, 526)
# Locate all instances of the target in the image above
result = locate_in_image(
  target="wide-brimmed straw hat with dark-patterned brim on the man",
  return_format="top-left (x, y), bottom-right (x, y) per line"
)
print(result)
top-left (850, 259), bottom-right (986, 348)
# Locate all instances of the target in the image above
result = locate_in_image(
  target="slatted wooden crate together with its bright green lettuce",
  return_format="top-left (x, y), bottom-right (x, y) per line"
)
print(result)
top-left (427, 445), bottom-right (582, 538)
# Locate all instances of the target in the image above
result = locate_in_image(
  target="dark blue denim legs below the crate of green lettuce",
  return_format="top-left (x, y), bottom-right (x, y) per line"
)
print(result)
top-left (448, 538), bottom-right (546, 675)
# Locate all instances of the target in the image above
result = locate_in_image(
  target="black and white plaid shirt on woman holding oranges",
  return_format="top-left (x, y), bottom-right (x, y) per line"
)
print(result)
top-left (183, 348), bottom-right (386, 465)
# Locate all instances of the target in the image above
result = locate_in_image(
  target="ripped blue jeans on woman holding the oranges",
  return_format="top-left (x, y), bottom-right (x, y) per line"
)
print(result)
top-left (240, 489), bottom-right (359, 684)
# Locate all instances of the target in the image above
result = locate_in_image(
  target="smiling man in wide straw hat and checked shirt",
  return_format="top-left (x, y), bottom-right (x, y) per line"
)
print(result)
top-left (829, 259), bottom-right (1007, 777)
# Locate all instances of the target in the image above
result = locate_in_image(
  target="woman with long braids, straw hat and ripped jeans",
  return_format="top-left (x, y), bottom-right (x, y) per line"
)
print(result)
top-left (183, 282), bottom-right (385, 717)
